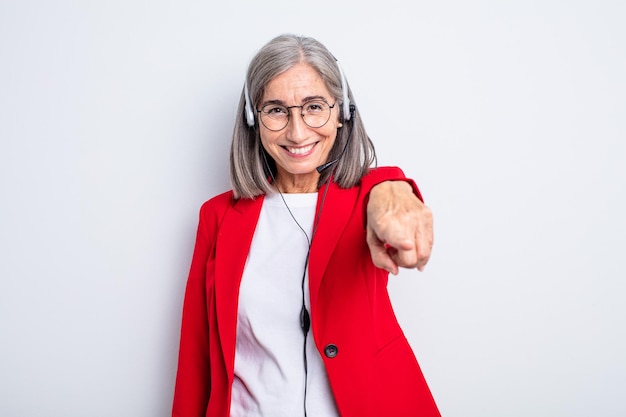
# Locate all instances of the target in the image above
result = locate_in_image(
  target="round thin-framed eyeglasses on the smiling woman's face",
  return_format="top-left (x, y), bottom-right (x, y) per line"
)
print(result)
top-left (257, 100), bottom-right (337, 132)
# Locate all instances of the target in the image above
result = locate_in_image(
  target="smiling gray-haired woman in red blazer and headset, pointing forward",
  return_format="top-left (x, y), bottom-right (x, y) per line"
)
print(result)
top-left (173, 35), bottom-right (439, 417)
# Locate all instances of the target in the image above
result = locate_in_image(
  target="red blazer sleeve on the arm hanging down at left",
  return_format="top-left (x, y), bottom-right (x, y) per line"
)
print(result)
top-left (172, 200), bottom-right (225, 417)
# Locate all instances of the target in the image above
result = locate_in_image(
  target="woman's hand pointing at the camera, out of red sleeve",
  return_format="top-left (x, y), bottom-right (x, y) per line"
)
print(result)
top-left (367, 181), bottom-right (433, 275)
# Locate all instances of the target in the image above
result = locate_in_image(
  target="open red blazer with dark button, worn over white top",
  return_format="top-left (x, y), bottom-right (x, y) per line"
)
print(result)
top-left (172, 167), bottom-right (440, 417)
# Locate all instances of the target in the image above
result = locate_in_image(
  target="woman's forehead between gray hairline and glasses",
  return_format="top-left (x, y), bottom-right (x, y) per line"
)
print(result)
top-left (263, 63), bottom-right (331, 103)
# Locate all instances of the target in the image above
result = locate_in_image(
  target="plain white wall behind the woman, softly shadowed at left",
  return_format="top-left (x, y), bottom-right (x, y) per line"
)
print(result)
top-left (0, 0), bottom-right (626, 417)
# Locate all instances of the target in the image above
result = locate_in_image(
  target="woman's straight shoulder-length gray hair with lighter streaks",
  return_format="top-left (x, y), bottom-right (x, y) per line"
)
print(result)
top-left (230, 35), bottom-right (376, 198)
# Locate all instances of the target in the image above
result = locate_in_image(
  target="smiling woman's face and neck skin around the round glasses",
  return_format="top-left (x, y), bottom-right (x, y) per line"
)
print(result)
top-left (258, 63), bottom-right (341, 193)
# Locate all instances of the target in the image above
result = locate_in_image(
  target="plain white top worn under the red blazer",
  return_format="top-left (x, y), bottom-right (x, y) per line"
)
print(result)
top-left (230, 193), bottom-right (339, 417)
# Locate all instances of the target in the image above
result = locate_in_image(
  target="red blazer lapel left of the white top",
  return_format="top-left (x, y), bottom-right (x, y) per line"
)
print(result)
top-left (215, 193), bottom-right (263, 380)
